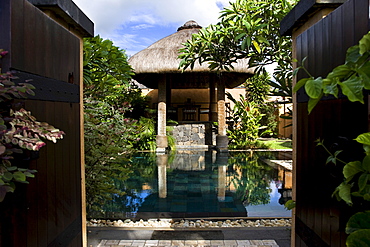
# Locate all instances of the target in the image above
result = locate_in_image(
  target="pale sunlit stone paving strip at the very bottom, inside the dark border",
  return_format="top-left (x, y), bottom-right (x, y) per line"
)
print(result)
top-left (98, 240), bottom-right (279, 247)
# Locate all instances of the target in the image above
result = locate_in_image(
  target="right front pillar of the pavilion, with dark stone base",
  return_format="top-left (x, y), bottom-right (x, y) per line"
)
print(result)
top-left (216, 79), bottom-right (229, 152)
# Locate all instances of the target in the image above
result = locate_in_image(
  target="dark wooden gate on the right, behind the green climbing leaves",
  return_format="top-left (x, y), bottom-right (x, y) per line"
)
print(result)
top-left (282, 0), bottom-right (369, 247)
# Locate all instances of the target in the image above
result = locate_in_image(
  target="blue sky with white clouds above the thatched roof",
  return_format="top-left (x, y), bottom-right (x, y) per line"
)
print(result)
top-left (73, 0), bottom-right (230, 56)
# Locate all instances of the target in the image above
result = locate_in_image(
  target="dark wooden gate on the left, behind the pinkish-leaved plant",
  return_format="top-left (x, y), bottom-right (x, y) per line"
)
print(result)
top-left (0, 0), bottom-right (93, 247)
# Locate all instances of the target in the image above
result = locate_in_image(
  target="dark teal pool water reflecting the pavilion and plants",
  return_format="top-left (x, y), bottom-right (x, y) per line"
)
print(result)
top-left (97, 151), bottom-right (292, 219)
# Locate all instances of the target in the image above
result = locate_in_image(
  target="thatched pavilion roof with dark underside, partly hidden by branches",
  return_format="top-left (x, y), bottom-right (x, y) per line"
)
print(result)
top-left (129, 21), bottom-right (253, 88)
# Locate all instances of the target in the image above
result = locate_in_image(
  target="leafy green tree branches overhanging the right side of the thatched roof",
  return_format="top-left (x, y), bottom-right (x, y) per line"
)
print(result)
top-left (180, 0), bottom-right (296, 70)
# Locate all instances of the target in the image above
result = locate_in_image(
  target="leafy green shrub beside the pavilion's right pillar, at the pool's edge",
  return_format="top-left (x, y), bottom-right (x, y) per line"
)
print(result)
top-left (227, 93), bottom-right (265, 149)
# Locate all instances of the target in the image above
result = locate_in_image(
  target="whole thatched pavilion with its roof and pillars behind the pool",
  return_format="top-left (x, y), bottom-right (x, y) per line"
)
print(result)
top-left (129, 21), bottom-right (253, 152)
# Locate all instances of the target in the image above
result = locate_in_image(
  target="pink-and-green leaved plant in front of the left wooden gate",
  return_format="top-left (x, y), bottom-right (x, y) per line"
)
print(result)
top-left (0, 52), bottom-right (64, 202)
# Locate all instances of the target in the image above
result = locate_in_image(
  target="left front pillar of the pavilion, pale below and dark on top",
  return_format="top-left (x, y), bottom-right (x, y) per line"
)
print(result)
top-left (156, 75), bottom-right (168, 153)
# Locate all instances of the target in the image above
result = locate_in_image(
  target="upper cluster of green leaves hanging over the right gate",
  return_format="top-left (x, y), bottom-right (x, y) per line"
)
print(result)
top-left (294, 32), bottom-right (370, 112)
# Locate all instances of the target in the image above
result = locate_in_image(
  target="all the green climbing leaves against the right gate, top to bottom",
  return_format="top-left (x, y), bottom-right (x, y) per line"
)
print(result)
top-left (294, 32), bottom-right (370, 246)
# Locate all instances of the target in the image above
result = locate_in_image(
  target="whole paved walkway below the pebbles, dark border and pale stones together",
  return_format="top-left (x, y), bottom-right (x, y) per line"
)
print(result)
top-left (87, 227), bottom-right (291, 247)
